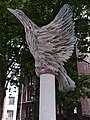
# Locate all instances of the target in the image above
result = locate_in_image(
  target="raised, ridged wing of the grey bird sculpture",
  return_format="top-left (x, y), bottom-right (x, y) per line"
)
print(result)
top-left (37, 4), bottom-right (76, 64)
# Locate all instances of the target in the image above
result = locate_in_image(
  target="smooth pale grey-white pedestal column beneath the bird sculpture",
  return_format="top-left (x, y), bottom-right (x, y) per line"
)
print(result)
top-left (39, 74), bottom-right (56, 120)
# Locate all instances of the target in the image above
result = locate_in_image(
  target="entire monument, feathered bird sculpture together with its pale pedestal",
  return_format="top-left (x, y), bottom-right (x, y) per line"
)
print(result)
top-left (8, 4), bottom-right (76, 120)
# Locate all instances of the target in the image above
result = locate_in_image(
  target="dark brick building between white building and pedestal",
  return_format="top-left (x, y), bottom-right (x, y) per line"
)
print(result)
top-left (17, 75), bottom-right (39, 120)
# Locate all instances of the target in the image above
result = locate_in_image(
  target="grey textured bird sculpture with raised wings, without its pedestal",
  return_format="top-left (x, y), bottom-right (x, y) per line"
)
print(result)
top-left (8, 4), bottom-right (76, 91)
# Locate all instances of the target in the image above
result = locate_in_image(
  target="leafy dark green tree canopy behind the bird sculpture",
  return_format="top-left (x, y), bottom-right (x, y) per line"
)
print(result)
top-left (0, 0), bottom-right (90, 118)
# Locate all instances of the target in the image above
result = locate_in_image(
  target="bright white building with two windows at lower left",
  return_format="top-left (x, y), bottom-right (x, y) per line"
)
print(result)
top-left (2, 83), bottom-right (18, 120)
